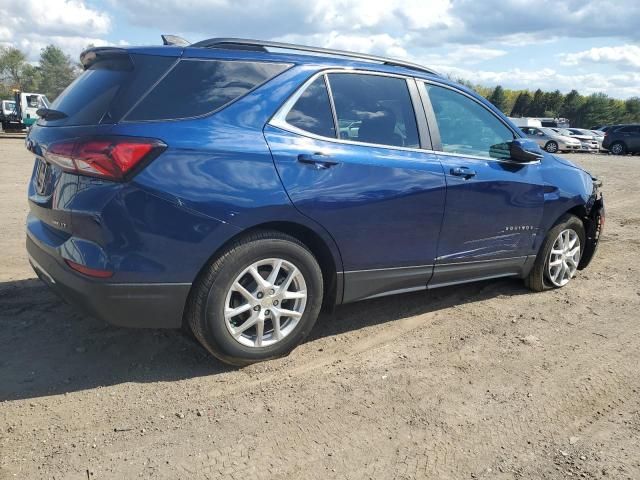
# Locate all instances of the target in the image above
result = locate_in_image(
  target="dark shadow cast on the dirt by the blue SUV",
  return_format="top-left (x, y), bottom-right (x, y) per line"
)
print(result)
top-left (0, 279), bottom-right (527, 401)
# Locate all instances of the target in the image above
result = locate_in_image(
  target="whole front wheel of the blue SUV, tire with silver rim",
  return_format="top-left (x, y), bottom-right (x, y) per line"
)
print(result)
top-left (525, 215), bottom-right (585, 292)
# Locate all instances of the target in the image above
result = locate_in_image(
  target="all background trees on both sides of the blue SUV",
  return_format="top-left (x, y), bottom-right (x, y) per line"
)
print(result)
top-left (0, 45), bottom-right (640, 128)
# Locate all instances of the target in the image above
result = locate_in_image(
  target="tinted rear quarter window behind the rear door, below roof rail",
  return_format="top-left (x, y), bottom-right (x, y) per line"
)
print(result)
top-left (126, 60), bottom-right (289, 121)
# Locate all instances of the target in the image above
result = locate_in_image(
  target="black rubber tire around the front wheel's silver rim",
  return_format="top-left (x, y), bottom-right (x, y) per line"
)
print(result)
top-left (524, 214), bottom-right (585, 292)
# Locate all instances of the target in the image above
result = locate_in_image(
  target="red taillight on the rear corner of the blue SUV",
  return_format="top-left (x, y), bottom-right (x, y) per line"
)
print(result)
top-left (44, 137), bottom-right (167, 180)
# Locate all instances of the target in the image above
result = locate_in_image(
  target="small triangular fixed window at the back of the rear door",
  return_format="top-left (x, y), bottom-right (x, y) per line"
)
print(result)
top-left (286, 76), bottom-right (336, 138)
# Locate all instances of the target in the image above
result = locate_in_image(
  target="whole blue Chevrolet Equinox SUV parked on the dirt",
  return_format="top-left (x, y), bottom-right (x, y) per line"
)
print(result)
top-left (26, 38), bottom-right (604, 365)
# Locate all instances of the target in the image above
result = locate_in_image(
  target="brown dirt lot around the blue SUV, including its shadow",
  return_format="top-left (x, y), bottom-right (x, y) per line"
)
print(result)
top-left (0, 139), bottom-right (640, 480)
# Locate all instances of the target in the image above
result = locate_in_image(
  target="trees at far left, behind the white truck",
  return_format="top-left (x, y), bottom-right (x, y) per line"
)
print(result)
top-left (0, 45), bottom-right (76, 101)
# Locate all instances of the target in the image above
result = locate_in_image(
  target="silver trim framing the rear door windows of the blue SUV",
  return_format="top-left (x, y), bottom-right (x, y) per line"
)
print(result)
top-left (267, 68), bottom-right (435, 153)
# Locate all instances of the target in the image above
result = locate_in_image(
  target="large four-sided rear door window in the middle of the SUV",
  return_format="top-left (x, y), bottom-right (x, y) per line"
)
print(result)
top-left (327, 73), bottom-right (420, 148)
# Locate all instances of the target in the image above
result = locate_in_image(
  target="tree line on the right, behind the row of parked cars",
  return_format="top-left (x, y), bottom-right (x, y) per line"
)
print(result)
top-left (463, 82), bottom-right (640, 128)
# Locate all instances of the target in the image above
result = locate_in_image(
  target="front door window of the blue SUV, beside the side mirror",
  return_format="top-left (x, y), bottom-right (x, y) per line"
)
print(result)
top-left (423, 84), bottom-right (514, 158)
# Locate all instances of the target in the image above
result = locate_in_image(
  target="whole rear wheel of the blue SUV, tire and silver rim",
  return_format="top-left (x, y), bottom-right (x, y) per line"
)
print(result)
top-left (187, 231), bottom-right (323, 366)
